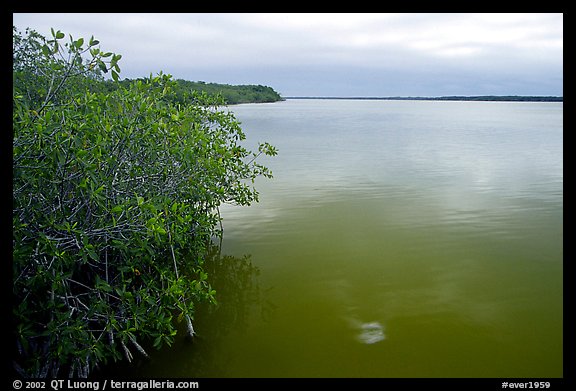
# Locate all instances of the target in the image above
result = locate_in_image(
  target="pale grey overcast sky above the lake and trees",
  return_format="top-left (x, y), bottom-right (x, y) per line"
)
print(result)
top-left (13, 13), bottom-right (564, 97)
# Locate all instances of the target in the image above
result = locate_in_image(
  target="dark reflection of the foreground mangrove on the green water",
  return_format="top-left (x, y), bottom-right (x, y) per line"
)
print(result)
top-left (95, 244), bottom-right (274, 378)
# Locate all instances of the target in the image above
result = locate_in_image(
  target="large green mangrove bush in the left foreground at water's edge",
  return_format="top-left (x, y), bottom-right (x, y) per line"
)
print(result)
top-left (12, 29), bottom-right (276, 377)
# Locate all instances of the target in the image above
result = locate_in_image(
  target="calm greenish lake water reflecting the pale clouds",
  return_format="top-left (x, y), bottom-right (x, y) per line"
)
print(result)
top-left (118, 100), bottom-right (563, 378)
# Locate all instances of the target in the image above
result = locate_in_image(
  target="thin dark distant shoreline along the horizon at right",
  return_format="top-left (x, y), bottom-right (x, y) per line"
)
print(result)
top-left (283, 95), bottom-right (564, 102)
